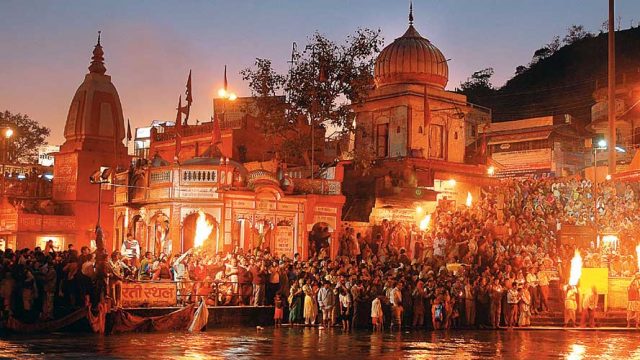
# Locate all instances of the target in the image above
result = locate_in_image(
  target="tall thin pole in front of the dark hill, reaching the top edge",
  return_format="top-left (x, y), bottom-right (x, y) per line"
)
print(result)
top-left (607, 0), bottom-right (616, 175)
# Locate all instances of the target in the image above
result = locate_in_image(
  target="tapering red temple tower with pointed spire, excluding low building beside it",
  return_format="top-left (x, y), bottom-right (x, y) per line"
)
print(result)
top-left (53, 35), bottom-right (130, 249)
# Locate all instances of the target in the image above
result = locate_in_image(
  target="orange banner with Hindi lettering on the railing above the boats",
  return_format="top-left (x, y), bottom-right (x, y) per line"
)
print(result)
top-left (122, 282), bottom-right (177, 308)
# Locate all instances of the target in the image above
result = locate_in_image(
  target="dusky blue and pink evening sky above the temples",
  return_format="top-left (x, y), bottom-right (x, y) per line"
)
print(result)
top-left (0, 0), bottom-right (640, 144)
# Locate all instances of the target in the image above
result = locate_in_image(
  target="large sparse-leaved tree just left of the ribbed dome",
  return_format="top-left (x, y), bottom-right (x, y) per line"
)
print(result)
top-left (241, 29), bottom-right (382, 165)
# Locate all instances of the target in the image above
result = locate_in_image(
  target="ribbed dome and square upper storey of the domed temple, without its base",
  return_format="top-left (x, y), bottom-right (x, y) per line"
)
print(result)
top-left (355, 6), bottom-right (467, 163)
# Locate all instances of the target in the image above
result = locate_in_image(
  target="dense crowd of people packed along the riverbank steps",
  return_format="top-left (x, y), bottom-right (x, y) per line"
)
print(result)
top-left (0, 174), bottom-right (640, 330)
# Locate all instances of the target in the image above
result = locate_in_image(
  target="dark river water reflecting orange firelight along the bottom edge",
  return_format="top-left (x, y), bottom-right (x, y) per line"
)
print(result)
top-left (0, 328), bottom-right (640, 360)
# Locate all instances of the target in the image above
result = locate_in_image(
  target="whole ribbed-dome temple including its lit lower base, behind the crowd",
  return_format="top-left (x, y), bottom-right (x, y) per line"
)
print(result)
top-left (345, 7), bottom-right (491, 223)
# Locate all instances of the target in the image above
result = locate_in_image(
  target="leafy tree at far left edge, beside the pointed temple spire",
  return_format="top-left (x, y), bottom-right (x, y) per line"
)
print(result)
top-left (0, 110), bottom-right (51, 163)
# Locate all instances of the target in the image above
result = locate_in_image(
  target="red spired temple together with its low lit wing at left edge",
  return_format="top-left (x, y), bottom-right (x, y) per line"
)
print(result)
top-left (0, 36), bottom-right (130, 249)
